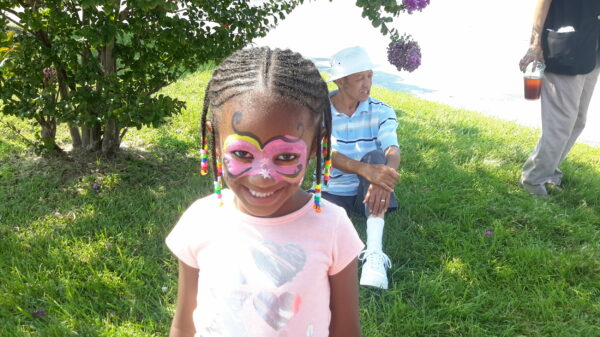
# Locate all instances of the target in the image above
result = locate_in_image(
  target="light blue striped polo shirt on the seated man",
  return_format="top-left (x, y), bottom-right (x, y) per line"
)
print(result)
top-left (323, 90), bottom-right (398, 196)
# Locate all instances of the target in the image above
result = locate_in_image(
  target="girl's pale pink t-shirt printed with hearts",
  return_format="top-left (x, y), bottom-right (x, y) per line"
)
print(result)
top-left (166, 190), bottom-right (364, 337)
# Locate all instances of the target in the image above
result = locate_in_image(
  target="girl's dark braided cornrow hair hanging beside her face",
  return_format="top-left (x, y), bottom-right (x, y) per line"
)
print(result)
top-left (200, 47), bottom-right (331, 190)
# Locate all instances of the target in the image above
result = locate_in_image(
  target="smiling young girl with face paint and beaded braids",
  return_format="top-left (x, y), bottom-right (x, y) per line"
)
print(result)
top-left (166, 48), bottom-right (363, 337)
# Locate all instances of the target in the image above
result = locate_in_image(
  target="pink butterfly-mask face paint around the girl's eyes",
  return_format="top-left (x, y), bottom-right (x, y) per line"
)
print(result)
top-left (223, 134), bottom-right (307, 183)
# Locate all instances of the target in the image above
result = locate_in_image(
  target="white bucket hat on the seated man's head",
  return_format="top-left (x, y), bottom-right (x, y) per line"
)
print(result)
top-left (328, 46), bottom-right (376, 82)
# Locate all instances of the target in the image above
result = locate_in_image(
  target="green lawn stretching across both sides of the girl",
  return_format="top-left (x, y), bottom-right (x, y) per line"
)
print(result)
top-left (0, 72), bottom-right (600, 337)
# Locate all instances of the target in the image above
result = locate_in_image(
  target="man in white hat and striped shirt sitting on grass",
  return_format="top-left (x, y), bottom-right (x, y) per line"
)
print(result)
top-left (323, 47), bottom-right (400, 289)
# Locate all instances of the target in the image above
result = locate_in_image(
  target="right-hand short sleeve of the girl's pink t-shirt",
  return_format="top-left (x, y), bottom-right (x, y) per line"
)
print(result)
top-left (328, 208), bottom-right (365, 276)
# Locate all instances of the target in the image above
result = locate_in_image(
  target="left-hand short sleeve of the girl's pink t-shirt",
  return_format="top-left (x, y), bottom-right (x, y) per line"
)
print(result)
top-left (165, 200), bottom-right (207, 269)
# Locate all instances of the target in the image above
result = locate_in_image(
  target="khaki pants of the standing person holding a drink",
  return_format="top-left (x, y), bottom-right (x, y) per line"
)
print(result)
top-left (521, 59), bottom-right (600, 186)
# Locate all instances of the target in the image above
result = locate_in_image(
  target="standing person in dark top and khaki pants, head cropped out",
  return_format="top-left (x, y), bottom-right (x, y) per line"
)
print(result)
top-left (519, 0), bottom-right (600, 196)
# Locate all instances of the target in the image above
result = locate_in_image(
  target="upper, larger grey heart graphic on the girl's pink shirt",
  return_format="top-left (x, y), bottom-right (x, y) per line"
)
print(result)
top-left (251, 242), bottom-right (306, 287)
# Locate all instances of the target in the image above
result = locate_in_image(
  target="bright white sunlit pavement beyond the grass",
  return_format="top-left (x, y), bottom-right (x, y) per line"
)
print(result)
top-left (255, 0), bottom-right (600, 146)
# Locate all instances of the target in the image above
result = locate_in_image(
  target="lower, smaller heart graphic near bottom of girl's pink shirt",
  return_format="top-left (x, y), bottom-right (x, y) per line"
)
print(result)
top-left (253, 291), bottom-right (302, 330)
